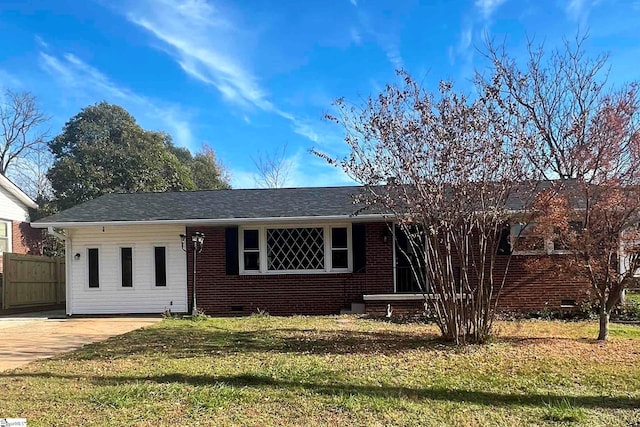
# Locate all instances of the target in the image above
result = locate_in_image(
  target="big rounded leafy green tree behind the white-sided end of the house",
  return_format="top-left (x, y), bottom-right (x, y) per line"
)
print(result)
top-left (48, 102), bottom-right (196, 209)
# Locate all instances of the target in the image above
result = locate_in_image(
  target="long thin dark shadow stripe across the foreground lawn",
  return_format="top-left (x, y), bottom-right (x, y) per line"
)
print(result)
top-left (0, 373), bottom-right (640, 409)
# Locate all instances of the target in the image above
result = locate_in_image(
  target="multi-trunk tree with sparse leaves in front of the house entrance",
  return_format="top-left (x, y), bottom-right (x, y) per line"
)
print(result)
top-left (317, 73), bottom-right (533, 344)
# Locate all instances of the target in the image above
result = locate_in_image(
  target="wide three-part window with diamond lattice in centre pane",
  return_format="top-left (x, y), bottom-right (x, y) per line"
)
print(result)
top-left (238, 224), bottom-right (352, 274)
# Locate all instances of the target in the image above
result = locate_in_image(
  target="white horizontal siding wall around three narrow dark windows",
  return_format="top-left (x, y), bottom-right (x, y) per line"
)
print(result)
top-left (67, 225), bottom-right (187, 314)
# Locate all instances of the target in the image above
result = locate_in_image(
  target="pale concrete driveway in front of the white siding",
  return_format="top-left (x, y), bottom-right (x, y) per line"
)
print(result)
top-left (0, 312), bottom-right (162, 371)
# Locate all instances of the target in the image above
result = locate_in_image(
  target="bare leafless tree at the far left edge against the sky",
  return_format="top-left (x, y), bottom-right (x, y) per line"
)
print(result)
top-left (0, 90), bottom-right (49, 175)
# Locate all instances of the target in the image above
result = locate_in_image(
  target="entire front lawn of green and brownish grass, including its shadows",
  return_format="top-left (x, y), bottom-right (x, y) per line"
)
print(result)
top-left (0, 316), bottom-right (640, 426)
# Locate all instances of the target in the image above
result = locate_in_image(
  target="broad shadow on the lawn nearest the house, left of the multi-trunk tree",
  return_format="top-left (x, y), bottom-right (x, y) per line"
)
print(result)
top-left (61, 322), bottom-right (444, 360)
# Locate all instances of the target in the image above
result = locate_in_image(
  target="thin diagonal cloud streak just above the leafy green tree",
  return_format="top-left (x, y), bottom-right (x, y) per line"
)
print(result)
top-left (40, 52), bottom-right (194, 148)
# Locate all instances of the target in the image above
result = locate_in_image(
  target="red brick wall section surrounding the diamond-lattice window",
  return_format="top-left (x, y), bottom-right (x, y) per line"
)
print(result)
top-left (187, 223), bottom-right (393, 315)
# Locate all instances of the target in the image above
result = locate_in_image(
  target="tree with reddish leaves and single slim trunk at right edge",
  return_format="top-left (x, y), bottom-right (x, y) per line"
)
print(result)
top-left (484, 36), bottom-right (640, 340)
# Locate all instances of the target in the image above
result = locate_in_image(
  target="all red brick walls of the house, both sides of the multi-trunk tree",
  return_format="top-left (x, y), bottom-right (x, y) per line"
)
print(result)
top-left (187, 223), bottom-right (589, 315)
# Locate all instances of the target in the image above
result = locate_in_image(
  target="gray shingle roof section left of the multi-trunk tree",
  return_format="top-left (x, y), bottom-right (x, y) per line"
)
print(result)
top-left (35, 186), bottom-right (372, 224)
